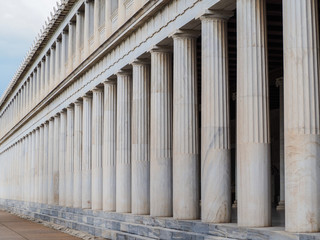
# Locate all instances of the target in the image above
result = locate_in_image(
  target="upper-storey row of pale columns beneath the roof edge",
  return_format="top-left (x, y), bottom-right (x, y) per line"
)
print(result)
top-left (0, 0), bottom-right (147, 137)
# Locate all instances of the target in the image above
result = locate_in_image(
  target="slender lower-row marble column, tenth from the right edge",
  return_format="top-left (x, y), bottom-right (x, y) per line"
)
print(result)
top-left (82, 95), bottom-right (92, 208)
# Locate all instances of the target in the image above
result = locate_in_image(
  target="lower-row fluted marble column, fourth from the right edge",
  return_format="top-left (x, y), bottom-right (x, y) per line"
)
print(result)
top-left (173, 31), bottom-right (200, 220)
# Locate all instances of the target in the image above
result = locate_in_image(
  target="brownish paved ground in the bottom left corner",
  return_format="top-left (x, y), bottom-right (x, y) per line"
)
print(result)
top-left (0, 211), bottom-right (79, 240)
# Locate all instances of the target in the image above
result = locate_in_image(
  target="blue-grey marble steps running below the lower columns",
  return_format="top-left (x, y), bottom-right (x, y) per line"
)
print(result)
top-left (0, 199), bottom-right (320, 240)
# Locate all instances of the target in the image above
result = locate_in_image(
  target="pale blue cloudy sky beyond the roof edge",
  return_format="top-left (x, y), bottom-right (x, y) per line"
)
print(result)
top-left (0, 0), bottom-right (60, 98)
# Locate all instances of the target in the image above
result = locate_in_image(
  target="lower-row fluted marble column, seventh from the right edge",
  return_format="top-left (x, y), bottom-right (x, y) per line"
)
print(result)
top-left (116, 71), bottom-right (132, 213)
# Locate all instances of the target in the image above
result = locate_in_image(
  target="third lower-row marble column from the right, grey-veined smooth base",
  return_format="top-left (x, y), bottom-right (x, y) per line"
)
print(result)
top-left (201, 12), bottom-right (231, 223)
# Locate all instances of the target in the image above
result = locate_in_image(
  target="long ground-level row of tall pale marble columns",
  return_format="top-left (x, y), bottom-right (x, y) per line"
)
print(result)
top-left (0, 0), bottom-right (320, 232)
